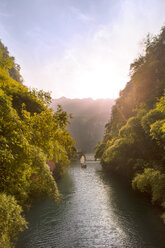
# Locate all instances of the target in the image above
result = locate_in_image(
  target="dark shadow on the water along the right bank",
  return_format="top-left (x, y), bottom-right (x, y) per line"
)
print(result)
top-left (96, 172), bottom-right (165, 248)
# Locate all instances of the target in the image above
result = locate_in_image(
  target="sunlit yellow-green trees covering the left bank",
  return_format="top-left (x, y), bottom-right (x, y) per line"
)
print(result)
top-left (0, 40), bottom-right (76, 247)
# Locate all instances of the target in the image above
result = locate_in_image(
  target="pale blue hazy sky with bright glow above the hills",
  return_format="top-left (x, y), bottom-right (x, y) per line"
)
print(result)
top-left (0, 0), bottom-right (165, 98)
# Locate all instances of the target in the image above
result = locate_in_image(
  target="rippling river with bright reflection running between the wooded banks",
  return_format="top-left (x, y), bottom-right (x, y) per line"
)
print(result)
top-left (16, 159), bottom-right (165, 248)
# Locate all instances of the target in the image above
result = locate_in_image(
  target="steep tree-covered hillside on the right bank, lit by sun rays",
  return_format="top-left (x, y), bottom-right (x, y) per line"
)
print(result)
top-left (96, 27), bottom-right (165, 221)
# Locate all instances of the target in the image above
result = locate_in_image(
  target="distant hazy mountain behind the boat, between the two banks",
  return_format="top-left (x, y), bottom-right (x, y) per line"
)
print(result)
top-left (51, 97), bottom-right (114, 152)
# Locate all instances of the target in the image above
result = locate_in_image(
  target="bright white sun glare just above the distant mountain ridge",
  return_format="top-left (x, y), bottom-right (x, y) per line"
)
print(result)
top-left (73, 62), bottom-right (128, 99)
